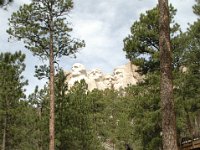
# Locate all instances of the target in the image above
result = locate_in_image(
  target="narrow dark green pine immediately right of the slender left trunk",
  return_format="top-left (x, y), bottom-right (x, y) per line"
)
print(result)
top-left (55, 70), bottom-right (69, 150)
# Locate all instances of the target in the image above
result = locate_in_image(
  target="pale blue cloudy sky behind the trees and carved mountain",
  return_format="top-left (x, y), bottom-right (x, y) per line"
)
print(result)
top-left (0, 0), bottom-right (197, 94)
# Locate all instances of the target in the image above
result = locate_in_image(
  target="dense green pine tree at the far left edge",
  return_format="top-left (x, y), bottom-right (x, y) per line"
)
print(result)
top-left (0, 52), bottom-right (27, 150)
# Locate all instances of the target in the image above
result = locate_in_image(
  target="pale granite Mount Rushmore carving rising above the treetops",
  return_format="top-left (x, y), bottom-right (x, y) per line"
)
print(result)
top-left (65, 63), bottom-right (141, 91)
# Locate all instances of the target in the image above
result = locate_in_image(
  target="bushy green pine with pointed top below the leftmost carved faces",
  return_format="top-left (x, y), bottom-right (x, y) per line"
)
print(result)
top-left (60, 80), bottom-right (101, 150)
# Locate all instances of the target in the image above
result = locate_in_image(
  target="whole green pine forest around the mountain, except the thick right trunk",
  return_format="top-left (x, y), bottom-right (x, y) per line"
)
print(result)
top-left (0, 0), bottom-right (200, 150)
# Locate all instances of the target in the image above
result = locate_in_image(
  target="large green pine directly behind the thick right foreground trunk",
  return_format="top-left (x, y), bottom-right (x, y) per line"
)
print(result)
top-left (123, 5), bottom-right (182, 149)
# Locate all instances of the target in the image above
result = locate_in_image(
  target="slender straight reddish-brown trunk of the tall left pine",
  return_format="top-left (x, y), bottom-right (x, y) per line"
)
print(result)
top-left (49, 20), bottom-right (55, 150)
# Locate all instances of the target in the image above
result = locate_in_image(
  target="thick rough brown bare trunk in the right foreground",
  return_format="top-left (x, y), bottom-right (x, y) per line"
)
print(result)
top-left (158, 0), bottom-right (178, 150)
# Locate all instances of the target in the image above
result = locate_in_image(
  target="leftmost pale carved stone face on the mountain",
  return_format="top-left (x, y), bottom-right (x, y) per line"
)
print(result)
top-left (72, 63), bottom-right (86, 77)
